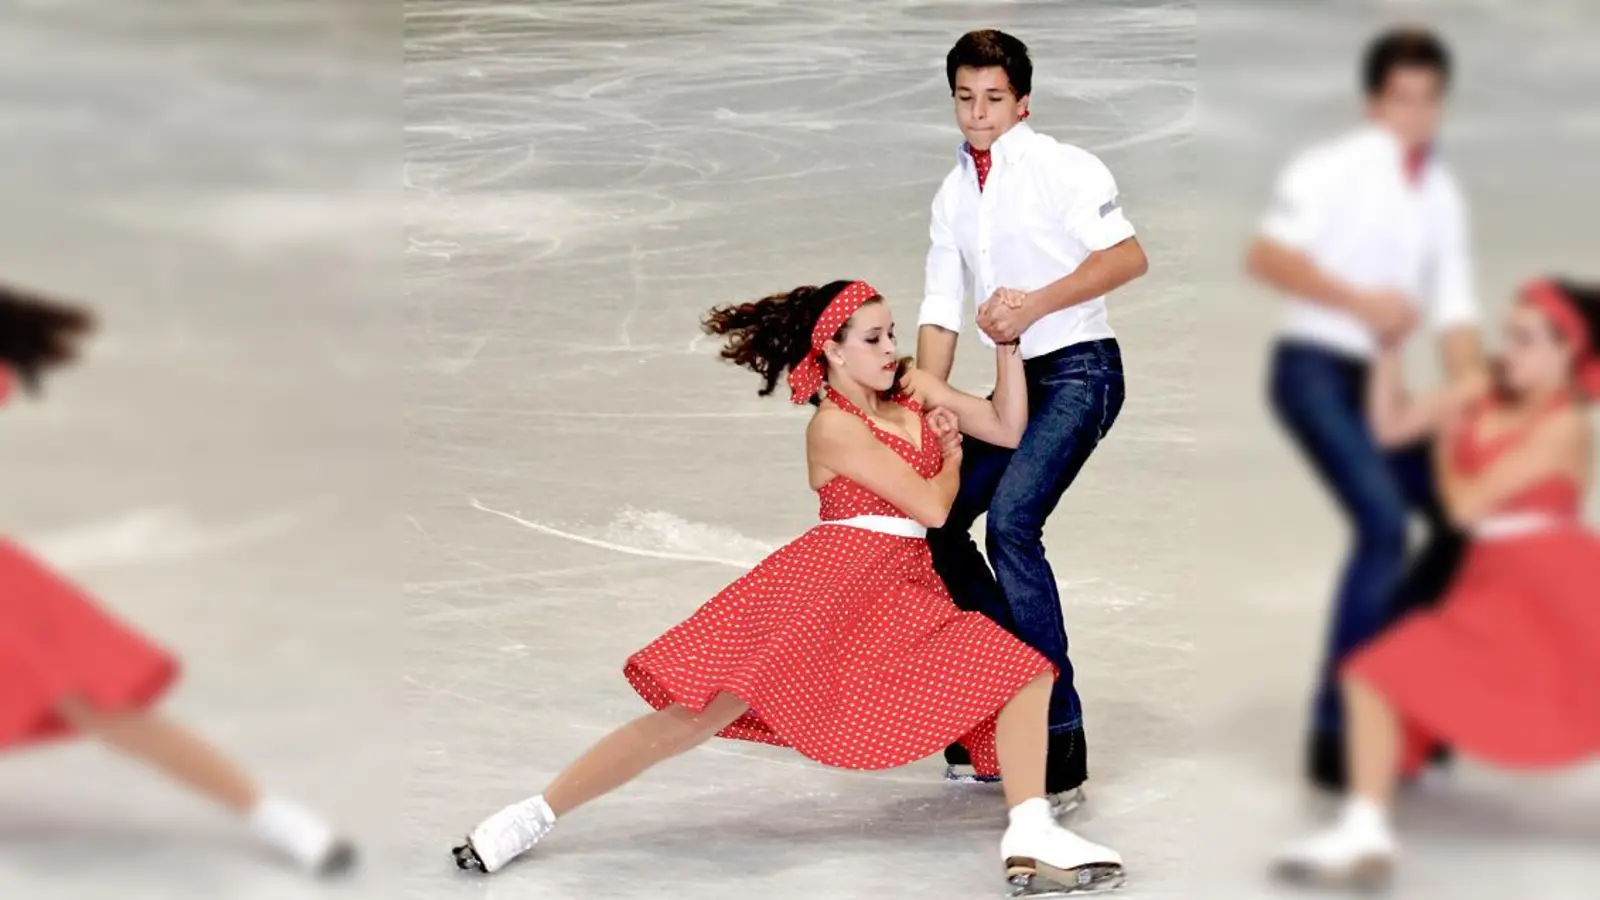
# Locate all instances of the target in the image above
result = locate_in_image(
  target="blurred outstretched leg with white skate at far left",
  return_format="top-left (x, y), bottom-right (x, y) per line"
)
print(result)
top-left (56, 698), bottom-right (355, 874)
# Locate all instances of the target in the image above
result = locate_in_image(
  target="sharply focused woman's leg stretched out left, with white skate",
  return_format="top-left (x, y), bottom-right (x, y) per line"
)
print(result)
top-left (454, 693), bottom-right (749, 873)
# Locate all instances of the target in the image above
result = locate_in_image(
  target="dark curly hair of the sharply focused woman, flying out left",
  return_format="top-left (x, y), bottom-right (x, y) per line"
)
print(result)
top-left (701, 279), bottom-right (910, 405)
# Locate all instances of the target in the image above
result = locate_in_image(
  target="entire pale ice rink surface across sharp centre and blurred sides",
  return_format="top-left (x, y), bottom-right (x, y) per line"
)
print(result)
top-left (0, 0), bottom-right (1600, 900)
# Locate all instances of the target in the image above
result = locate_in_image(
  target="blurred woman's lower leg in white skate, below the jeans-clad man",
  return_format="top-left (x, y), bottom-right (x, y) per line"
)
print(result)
top-left (1278, 677), bottom-right (1402, 887)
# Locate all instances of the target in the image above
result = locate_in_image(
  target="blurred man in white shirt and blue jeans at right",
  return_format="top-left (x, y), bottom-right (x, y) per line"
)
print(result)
top-left (1248, 29), bottom-right (1482, 790)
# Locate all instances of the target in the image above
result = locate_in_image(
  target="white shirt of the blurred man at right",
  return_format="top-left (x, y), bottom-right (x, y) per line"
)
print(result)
top-left (1261, 125), bottom-right (1478, 359)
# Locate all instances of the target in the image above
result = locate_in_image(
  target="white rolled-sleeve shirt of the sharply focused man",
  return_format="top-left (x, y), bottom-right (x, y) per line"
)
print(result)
top-left (917, 122), bottom-right (1133, 359)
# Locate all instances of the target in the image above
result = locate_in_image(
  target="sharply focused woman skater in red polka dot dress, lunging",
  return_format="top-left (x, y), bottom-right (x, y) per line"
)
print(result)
top-left (454, 282), bottom-right (1123, 890)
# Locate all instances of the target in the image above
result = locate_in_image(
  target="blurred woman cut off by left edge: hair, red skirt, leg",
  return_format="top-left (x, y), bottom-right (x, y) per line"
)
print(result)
top-left (0, 287), bottom-right (355, 874)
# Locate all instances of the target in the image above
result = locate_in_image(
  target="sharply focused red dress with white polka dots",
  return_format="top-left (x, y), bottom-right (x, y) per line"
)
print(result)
top-left (624, 389), bottom-right (1053, 775)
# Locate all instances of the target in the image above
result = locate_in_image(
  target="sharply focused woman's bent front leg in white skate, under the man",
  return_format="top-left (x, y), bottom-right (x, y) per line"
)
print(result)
top-left (995, 674), bottom-right (1123, 890)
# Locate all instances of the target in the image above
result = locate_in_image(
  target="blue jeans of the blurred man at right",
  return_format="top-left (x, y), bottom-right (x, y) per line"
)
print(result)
top-left (1270, 341), bottom-right (1466, 737)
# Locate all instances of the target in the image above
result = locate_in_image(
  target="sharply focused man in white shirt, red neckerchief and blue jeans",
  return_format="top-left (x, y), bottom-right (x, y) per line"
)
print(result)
top-left (917, 30), bottom-right (1149, 797)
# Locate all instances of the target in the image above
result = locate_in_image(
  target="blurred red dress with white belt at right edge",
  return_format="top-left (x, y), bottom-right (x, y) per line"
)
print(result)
top-left (1346, 400), bottom-right (1600, 770)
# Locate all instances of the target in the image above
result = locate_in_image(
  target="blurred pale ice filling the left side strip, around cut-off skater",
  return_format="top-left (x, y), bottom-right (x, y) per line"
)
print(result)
top-left (0, 0), bottom-right (403, 900)
